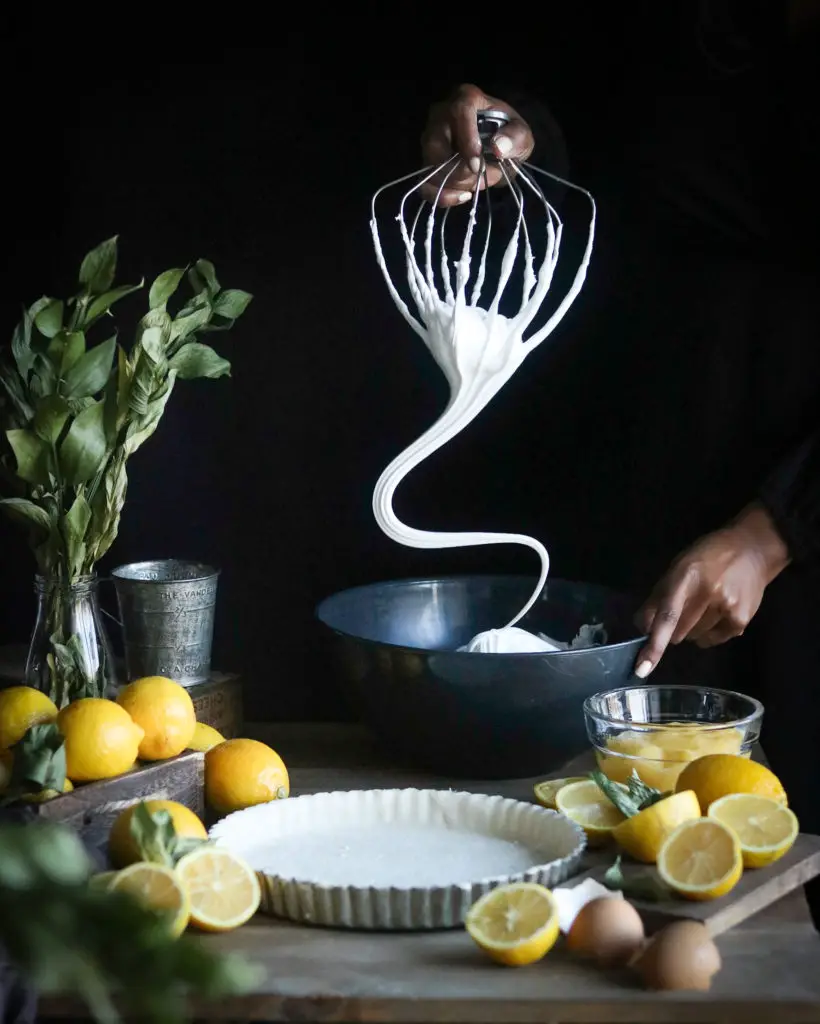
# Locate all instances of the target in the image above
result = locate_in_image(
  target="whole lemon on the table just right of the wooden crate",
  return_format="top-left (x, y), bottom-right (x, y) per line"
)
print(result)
top-left (205, 739), bottom-right (291, 814)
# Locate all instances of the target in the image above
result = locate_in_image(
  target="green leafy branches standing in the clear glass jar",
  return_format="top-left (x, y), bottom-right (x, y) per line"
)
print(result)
top-left (0, 238), bottom-right (252, 703)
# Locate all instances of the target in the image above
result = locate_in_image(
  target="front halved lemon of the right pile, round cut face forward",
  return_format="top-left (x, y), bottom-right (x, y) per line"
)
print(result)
top-left (657, 818), bottom-right (743, 900)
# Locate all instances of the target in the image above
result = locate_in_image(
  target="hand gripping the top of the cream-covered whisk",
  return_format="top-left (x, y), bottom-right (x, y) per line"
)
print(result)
top-left (422, 85), bottom-right (535, 206)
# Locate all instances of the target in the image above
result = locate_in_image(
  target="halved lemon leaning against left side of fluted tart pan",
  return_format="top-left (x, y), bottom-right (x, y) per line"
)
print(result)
top-left (176, 845), bottom-right (261, 932)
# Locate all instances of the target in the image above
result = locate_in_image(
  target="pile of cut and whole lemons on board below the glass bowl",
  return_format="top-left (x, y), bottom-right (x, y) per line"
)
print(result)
top-left (534, 754), bottom-right (800, 900)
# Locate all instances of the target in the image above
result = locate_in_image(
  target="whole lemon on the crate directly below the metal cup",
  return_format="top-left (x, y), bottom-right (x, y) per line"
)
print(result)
top-left (117, 676), bottom-right (197, 761)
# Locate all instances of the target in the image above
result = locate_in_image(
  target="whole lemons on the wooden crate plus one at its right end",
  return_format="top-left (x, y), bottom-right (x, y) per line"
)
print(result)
top-left (0, 676), bottom-right (290, 814)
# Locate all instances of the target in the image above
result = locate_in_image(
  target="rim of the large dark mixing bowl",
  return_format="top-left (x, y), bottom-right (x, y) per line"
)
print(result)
top-left (313, 572), bottom-right (649, 655)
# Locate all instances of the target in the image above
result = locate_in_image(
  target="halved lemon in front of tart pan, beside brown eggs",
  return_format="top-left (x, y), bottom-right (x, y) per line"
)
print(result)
top-left (465, 882), bottom-right (558, 967)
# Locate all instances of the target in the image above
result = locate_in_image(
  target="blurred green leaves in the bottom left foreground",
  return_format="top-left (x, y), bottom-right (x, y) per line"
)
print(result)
top-left (0, 822), bottom-right (261, 1024)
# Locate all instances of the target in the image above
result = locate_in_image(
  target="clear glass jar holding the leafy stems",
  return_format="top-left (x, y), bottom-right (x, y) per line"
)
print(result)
top-left (26, 575), bottom-right (117, 708)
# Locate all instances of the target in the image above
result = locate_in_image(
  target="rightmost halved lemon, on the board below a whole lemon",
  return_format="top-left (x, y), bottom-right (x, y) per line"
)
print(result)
top-left (708, 793), bottom-right (800, 867)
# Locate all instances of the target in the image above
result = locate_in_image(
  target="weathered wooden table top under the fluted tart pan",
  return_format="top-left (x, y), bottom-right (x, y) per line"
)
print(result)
top-left (41, 724), bottom-right (820, 1024)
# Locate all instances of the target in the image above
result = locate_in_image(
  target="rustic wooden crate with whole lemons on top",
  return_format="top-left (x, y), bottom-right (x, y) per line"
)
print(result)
top-left (31, 751), bottom-right (205, 847)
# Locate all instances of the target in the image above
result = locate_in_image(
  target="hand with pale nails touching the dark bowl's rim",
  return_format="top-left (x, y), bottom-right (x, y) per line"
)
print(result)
top-left (635, 505), bottom-right (790, 679)
